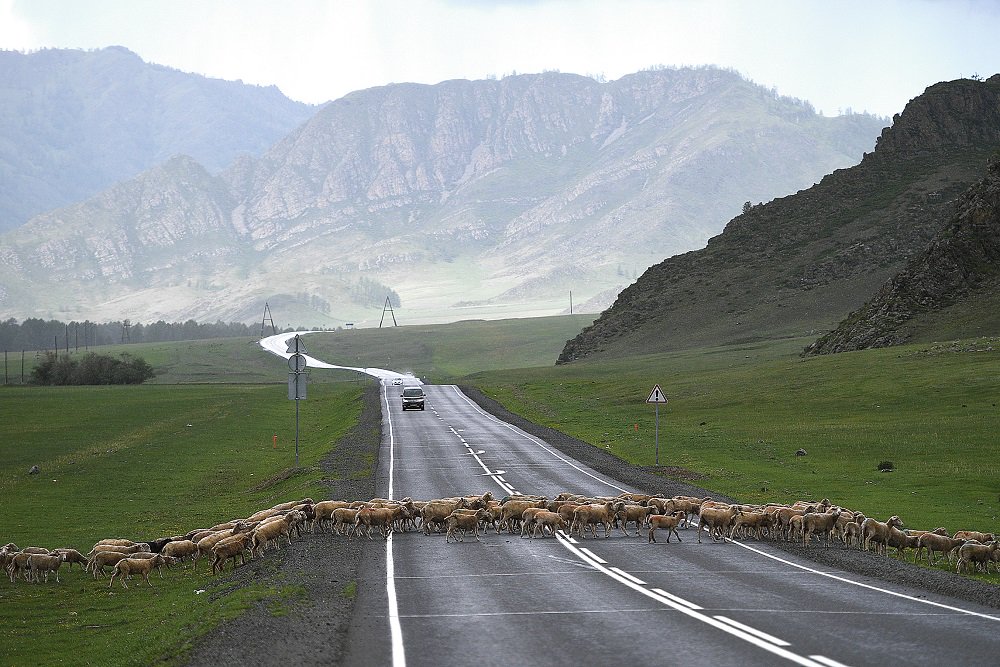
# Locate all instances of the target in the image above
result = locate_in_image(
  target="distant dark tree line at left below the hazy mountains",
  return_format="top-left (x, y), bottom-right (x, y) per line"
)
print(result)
top-left (0, 318), bottom-right (291, 352)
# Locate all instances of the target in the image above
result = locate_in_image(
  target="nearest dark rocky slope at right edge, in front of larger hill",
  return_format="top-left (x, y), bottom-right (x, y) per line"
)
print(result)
top-left (807, 154), bottom-right (1000, 354)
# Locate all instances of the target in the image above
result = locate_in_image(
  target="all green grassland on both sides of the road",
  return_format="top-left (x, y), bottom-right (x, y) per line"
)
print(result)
top-left (0, 316), bottom-right (1000, 665)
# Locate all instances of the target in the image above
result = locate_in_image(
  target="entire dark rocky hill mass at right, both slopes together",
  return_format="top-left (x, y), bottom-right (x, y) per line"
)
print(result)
top-left (559, 74), bottom-right (1000, 363)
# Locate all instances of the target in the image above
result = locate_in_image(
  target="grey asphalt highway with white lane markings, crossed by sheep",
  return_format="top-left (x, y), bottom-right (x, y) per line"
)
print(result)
top-left (265, 339), bottom-right (1000, 667)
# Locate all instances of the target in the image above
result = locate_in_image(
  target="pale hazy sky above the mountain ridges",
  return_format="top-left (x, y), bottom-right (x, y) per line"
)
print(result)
top-left (0, 0), bottom-right (1000, 116)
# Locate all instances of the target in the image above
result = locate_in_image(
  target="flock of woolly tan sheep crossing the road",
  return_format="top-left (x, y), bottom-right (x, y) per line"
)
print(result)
top-left (0, 492), bottom-right (1000, 588)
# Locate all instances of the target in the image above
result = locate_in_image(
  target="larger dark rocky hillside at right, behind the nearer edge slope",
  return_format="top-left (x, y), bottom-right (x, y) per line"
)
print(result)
top-left (559, 75), bottom-right (1000, 363)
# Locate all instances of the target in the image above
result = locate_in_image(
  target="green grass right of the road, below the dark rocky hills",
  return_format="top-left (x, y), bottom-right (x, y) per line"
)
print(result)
top-left (467, 341), bottom-right (1000, 531)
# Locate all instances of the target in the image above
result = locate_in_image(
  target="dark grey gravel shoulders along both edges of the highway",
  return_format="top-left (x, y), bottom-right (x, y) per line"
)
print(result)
top-left (186, 383), bottom-right (1000, 667)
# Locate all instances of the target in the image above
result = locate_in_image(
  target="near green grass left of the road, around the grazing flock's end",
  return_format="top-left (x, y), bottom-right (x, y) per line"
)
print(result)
top-left (0, 378), bottom-right (361, 665)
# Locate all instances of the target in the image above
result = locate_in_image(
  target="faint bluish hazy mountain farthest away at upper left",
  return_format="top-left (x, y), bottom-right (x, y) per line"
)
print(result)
top-left (0, 47), bottom-right (315, 231)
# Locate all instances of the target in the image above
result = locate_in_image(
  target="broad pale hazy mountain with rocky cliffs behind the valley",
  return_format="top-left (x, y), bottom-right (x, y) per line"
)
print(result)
top-left (0, 68), bottom-right (883, 326)
